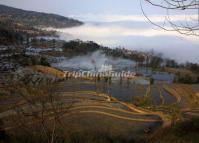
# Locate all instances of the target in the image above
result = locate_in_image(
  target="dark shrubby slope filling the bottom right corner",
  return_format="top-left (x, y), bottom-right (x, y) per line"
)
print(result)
top-left (150, 118), bottom-right (199, 143)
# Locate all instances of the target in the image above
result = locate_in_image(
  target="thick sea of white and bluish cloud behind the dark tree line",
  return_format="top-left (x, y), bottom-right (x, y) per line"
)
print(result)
top-left (52, 21), bottom-right (199, 63)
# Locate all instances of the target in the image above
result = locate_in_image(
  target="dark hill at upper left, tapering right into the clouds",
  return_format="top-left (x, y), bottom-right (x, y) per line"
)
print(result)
top-left (0, 5), bottom-right (83, 45)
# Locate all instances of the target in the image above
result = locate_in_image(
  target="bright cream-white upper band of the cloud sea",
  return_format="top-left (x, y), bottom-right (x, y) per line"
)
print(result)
top-left (48, 24), bottom-right (199, 43)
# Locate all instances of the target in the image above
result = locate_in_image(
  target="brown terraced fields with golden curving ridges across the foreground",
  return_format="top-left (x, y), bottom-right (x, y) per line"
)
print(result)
top-left (0, 76), bottom-right (199, 141)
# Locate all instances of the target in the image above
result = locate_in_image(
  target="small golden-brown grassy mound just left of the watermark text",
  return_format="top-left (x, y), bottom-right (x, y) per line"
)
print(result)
top-left (32, 65), bottom-right (64, 79)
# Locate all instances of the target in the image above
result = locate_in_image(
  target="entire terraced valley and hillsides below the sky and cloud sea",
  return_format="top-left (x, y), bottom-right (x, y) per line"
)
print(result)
top-left (0, 5), bottom-right (199, 143)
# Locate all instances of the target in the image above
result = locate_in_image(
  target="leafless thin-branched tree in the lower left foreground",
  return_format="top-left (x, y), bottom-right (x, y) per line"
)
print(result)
top-left (9, 86), bottom-right (72, 143)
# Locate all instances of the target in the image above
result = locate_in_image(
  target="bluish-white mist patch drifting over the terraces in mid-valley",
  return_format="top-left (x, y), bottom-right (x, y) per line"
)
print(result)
top-left (52, 51), bottom-right (135, 71)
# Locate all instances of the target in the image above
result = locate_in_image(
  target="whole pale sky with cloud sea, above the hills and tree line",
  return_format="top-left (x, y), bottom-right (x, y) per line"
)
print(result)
top-left (0, 0), bottom-right (199, 63)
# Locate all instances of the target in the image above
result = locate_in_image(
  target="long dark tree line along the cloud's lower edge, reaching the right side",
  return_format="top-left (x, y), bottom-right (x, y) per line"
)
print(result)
top-left (63, 40), bottom-right (198, 77)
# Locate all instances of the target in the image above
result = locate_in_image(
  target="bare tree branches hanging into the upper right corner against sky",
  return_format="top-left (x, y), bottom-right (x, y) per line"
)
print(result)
top-left (140, 0), bottom-right (199, 36)
